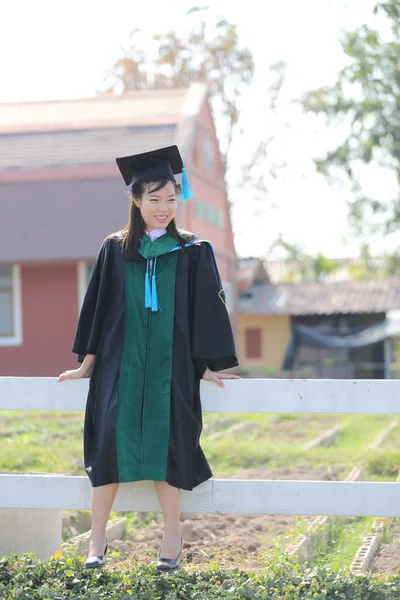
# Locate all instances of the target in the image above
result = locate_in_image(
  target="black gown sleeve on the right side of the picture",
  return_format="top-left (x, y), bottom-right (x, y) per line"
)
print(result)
top-left (192, 242), bottom-right (239, 377)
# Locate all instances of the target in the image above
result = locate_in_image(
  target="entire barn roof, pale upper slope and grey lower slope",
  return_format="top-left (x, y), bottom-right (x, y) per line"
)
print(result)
top-left (0, 84), bottom-right (207, 263)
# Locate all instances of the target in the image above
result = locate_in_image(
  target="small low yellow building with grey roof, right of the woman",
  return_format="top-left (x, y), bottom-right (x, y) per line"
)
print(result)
top-left (238, 274), bottom-right (400, 379)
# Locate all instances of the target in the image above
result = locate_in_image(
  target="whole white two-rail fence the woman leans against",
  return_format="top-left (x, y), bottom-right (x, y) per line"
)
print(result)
top-left (0, 377), bottom-right (400, 552)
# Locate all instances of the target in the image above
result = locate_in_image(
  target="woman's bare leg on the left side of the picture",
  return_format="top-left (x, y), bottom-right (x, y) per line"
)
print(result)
top-left (88, 483), bottom-right (119, 556)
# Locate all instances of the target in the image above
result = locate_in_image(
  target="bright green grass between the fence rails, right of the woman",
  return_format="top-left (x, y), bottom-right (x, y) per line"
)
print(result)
top-left (202, 415), bottom-right (400, 478)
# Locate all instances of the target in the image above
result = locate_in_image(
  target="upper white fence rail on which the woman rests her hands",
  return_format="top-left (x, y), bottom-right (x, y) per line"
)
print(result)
top-left (0, 377), bottom-right (400, 415)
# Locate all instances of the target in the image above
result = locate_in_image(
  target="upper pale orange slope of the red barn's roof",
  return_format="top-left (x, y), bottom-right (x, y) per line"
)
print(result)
top-left (0, 84), bottom-right (207, 172)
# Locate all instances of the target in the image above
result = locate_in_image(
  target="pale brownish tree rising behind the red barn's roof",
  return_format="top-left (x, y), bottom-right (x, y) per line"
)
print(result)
top-left (101, 7), bottom-right (254, 156)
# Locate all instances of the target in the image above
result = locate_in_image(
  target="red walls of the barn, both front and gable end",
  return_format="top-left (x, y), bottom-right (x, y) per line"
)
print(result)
top-left (0, 97), bottom-right (237, 377)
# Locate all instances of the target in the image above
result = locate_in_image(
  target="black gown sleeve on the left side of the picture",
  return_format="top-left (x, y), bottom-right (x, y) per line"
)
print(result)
top-left (72, 239), bottom-right (112, 362)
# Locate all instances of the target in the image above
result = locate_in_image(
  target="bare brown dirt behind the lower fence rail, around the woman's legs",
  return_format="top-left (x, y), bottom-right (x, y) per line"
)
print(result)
top-left (110, 466), bottom-right (340, 568)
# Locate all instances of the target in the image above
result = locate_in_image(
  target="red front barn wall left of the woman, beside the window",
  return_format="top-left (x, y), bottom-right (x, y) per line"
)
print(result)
top-left (0, 264), bottom-right (78, 377)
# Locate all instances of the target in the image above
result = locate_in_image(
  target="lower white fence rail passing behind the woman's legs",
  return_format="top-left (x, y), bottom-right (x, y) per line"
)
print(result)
top-left (0, 474), bottom-right (400, 517)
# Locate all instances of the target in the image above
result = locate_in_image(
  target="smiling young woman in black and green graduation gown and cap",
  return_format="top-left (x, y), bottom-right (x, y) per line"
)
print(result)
top-left (57, 146), bottom-right (238, 570)
